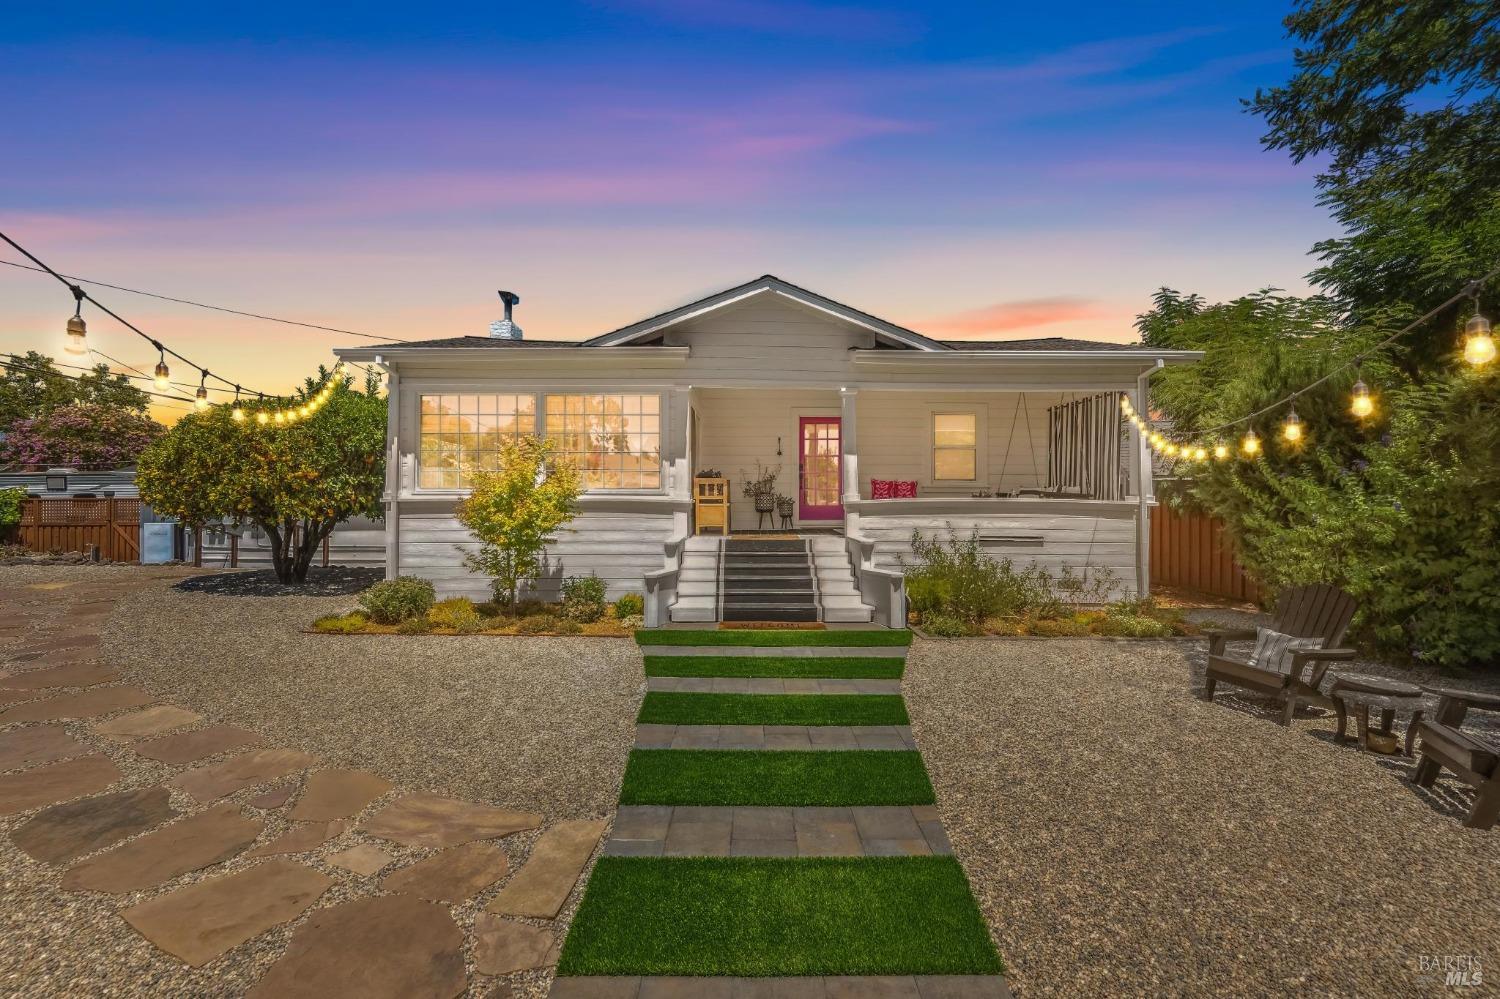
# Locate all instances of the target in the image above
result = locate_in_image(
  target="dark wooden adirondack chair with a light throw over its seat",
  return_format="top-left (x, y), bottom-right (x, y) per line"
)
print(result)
top-left (1200, 584), bottom-right (1359, 725)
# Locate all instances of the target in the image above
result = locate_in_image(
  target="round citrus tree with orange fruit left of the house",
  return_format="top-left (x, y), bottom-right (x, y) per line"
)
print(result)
top-left (137, 377), bottom-right (386, 584)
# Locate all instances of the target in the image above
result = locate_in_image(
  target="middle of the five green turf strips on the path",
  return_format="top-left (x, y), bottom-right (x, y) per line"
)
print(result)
top-left (636, 690), bottom-right (911, 725)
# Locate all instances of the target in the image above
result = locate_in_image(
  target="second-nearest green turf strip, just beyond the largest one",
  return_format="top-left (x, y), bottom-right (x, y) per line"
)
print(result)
top-left (620, 750), bottom-right (933, 806)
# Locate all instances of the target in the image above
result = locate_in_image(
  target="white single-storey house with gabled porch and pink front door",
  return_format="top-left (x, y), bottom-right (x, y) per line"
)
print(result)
top-left (336, 275), bottom-right (1200, 624)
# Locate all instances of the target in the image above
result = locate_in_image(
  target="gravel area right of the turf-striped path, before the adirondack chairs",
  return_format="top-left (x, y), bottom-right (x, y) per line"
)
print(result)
top-left (905, 639), bottom-right (1500, 996)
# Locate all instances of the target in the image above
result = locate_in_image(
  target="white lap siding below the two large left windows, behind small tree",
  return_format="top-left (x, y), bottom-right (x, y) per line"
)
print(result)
top-left (401, 512), bottom-right (672, 600)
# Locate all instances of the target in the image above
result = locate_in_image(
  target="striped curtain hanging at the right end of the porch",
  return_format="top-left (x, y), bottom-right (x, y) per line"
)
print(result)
top-left (1047, 392), bottom-right (1130, 500)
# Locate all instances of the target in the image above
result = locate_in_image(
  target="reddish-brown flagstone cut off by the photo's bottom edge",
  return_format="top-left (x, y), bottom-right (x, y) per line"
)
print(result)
top-left (249, 896), bottom-right (468, 999)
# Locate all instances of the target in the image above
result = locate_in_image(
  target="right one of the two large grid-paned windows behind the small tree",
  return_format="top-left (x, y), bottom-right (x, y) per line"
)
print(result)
top-left (546, 396), bottom-right (662, 489)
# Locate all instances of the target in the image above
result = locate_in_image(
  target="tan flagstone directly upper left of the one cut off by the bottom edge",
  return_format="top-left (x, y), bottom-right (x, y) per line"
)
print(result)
top-left (120, 860), bottom-right (338, 966)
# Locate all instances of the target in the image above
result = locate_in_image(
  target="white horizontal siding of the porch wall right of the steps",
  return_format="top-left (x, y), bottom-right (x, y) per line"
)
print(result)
top-left (860, 513), bottom-right (1136, 596)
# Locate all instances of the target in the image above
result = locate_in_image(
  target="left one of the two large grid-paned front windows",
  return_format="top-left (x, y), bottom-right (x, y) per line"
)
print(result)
top-left (419, 395), bottom-right (537, 489)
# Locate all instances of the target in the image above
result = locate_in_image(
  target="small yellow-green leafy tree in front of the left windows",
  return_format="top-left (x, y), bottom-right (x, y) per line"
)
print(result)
top-left (458, 437), bottom-right (581, 612)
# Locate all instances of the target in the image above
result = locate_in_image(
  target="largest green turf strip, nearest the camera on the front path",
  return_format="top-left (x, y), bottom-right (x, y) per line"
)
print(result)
top-left (558, 857), bottom-right (1005, 977)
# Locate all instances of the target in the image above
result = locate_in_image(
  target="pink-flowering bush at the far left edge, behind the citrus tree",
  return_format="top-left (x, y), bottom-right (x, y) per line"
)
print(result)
top-left (0, 405), bottom-right (165, 468)
